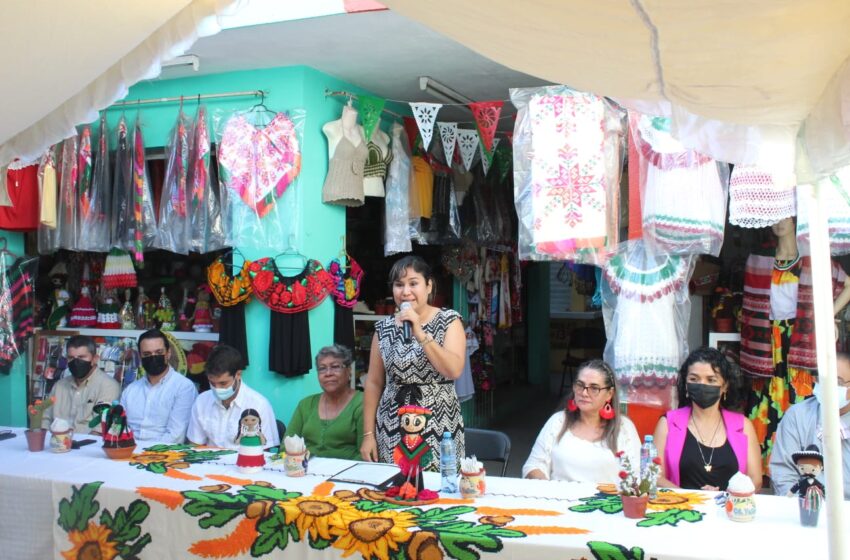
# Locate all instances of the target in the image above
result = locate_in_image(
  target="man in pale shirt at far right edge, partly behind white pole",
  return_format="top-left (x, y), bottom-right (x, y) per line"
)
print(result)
top-left (770, 352), bottom-right (850, 500)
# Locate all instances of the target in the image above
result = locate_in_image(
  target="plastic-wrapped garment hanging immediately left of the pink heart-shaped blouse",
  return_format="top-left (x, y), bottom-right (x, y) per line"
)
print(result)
top-left (188, 105), bottom-right (224, 254)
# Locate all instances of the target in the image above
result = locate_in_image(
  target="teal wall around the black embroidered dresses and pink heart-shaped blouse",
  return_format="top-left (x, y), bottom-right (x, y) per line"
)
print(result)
top-left (95, 67), bottom-right (372, 424)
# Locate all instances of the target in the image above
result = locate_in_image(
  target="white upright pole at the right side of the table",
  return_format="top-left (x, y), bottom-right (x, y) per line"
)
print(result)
top-left (809, 180), bottom-right (850, 560)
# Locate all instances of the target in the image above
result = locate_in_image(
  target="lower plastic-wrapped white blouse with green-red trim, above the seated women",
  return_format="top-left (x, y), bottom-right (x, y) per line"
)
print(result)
top-left (602, 241), bottom-right (695, 408)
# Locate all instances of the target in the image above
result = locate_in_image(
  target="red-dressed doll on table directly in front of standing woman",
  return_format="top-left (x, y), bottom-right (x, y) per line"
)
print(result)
top-left (386, 404), bottom-right (438, 502)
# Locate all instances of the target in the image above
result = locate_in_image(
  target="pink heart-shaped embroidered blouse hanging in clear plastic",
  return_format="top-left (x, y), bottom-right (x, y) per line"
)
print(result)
top-left (218, 113), bottom-right (301, 218)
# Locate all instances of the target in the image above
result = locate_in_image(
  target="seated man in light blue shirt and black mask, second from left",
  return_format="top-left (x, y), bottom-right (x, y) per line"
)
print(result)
top-left (121, 329), bottom-right (198, 443)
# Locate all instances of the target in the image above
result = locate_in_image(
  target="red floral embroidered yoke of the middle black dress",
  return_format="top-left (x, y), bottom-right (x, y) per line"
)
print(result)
top-left (249, 257), bottom-right (333, 313)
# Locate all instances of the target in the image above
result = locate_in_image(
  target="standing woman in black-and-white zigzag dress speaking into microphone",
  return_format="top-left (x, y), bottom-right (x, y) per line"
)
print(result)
top-left (360, 256), bottom-right (466, 471)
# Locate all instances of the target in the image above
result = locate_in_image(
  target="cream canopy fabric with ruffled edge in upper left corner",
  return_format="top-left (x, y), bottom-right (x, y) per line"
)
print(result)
top-left (0, 0), bottom-right (237, 166)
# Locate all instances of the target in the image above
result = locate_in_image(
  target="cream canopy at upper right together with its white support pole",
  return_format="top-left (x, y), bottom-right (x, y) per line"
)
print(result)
top-left (385, 0), bottom-right (850, 559)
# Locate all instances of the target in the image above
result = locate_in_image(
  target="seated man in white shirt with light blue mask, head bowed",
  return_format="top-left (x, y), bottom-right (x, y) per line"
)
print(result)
top-left (187, 344), bottom-right (280, 449)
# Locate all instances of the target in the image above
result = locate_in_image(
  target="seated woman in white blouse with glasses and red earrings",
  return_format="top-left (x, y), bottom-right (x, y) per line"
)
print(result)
top-left (522, 360), bottom-right (640, 484)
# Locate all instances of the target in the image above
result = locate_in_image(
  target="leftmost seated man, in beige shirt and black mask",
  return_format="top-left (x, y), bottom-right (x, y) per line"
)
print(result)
top-left (41, 335), bottom-right (121, 434)
